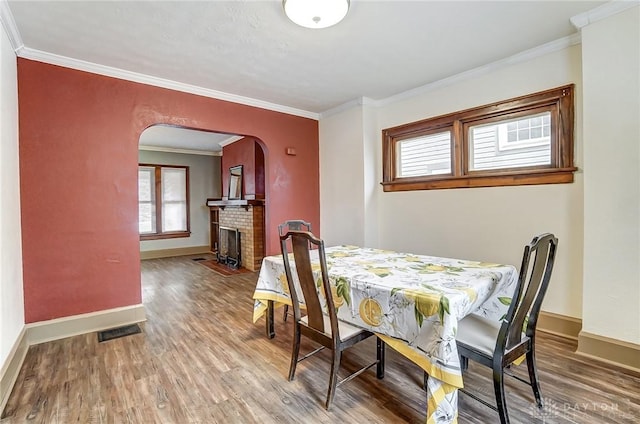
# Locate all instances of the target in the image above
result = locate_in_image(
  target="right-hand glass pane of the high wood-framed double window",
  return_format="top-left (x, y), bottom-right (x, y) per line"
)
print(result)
top-left (469, 112), bottom-right (551, 171)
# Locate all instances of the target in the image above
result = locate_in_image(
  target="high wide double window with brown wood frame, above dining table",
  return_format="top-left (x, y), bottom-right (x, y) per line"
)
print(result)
top-left (382, 85), bottom-right (576, 191)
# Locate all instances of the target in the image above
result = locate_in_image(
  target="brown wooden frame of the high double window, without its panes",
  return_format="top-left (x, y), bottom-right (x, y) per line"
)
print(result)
top-left (381, 84), bottom-right (577, 192)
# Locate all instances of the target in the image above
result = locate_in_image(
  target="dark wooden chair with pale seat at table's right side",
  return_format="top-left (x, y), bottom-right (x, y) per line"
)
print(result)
top-left (456, 233), bottom-right (558, 424)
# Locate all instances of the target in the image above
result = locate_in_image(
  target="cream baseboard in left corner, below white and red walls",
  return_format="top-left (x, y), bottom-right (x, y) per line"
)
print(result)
top-left (0, 304), bottom-right (147, 415)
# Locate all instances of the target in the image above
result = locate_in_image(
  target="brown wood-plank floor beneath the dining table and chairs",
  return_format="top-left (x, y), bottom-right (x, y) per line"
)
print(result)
top-left (0, 257), bottom-right (640, 424)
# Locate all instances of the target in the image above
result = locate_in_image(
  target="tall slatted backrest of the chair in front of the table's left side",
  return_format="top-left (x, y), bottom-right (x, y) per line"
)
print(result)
top-left (280, 230), bottom-right (340, 342)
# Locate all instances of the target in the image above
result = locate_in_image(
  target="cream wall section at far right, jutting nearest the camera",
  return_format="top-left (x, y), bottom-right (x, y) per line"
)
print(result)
top-left (582, 7), bottom-right (640, 343)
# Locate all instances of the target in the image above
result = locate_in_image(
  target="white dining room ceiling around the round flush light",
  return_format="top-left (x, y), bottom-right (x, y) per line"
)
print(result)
top-left (1, 0), bottom-right (605, 152)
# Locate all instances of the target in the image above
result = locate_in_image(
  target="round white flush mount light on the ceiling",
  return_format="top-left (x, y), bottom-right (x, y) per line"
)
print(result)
top-left (282, 0), bottom-right (349, 28)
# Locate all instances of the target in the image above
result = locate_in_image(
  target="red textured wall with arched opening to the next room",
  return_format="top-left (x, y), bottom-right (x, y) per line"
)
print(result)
top-left (18, 58), bottom-right (320, 323)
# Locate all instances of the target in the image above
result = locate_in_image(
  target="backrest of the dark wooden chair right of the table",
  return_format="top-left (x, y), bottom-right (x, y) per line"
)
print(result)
top-left (496, 233), bottom-right (558, 351)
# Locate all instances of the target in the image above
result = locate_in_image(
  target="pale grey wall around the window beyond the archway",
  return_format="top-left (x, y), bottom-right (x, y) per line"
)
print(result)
top-left (139, 150), bottom-right (221, 252)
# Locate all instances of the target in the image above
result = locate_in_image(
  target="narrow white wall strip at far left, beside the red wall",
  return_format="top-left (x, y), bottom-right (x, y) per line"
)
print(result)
top-left (0, 23), bottom-right (24, 369)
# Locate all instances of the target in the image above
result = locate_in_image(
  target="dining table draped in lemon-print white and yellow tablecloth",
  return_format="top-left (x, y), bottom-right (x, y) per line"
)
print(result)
top-left (253, 245), bottom-right (518, 424)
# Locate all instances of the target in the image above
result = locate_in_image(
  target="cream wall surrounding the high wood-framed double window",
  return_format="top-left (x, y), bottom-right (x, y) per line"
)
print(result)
top-left (320, 45), bottom-right (583, 317)
